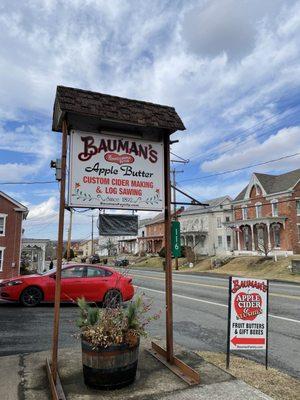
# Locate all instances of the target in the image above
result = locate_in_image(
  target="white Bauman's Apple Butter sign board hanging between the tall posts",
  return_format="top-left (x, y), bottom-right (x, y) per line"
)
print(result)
top-left (69, 131), bottom-right (164, 210)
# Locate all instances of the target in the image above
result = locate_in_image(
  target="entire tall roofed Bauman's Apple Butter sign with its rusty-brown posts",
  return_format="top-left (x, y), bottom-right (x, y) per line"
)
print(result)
top-left (46, 86), bottom-right (200, 400)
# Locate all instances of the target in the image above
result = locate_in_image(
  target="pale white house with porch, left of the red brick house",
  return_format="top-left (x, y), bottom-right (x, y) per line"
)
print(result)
top-left (179, 196), bottom-right (233, 256)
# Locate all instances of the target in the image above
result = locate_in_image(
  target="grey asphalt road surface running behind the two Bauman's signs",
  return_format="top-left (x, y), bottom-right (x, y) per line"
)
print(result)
top-left (0, 270), bottom-right (300, 378)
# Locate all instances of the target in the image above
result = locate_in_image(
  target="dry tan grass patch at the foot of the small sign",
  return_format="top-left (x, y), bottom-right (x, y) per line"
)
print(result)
top-left (198, 351), bottom-right (300, 400)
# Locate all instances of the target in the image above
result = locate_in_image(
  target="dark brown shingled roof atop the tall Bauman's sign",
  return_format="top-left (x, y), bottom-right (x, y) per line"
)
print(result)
top-left (52, 86), bottom-right (185, 132)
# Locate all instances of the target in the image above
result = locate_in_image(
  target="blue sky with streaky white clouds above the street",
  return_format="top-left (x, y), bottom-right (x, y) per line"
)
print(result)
top-left (0, 0), bottom-right (300, 239)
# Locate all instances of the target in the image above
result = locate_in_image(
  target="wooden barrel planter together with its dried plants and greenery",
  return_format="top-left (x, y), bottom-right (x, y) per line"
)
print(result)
top-left (78, 296), bottom-right (160, 390)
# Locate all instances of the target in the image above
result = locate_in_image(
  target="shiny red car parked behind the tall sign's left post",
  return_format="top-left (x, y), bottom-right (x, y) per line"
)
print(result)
top-left (0, 264), bottom-right (134, 307)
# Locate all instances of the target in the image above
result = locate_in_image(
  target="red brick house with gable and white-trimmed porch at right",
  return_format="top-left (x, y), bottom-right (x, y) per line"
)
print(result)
top-left (226, 169), bottom-right (300, 254)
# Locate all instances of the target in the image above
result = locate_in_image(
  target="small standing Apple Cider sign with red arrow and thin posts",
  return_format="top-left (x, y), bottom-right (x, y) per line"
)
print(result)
top-left (226, 277), bottom-right (269, 369)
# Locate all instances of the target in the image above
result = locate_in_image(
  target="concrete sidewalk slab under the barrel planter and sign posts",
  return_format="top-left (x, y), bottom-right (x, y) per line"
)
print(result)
top-left (0, 341), bottom-right (271, 400)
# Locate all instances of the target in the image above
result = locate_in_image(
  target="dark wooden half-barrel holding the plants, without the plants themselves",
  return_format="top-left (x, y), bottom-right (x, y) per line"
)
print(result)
top-left (81, 339), bottom-right (139, 390)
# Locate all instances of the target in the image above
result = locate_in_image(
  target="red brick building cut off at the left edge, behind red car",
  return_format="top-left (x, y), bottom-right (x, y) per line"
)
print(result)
top-left (0, 192), bottom-right (28, 280)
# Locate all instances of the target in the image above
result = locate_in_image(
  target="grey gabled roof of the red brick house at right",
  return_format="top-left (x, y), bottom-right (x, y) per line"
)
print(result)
top-left (234, 168), bottom-right (300, 201)
